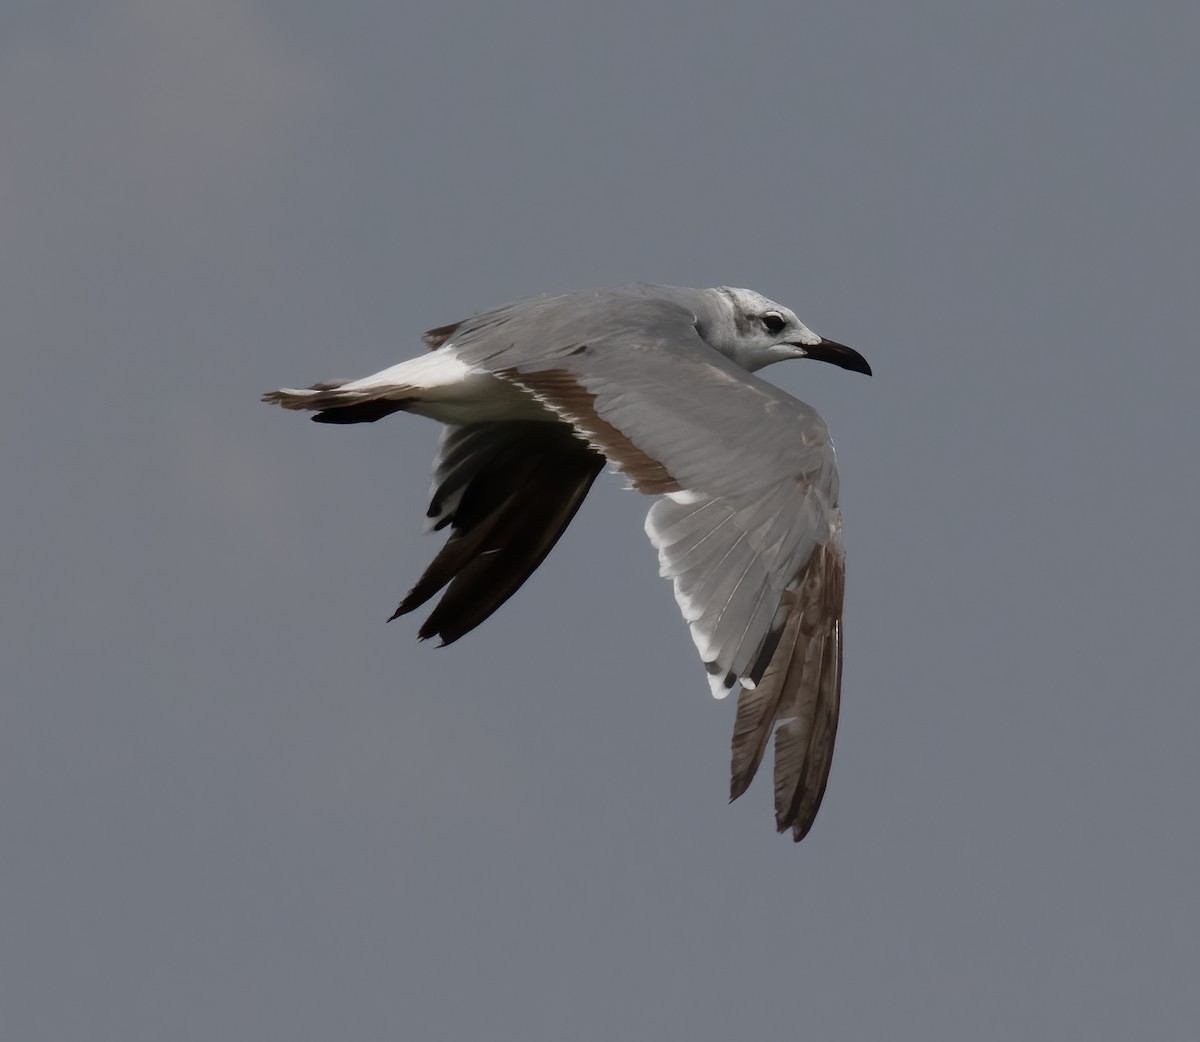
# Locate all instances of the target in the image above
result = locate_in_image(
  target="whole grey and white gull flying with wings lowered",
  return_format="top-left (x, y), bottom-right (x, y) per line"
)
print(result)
top-left (263, 283), bottom-right (871, 842)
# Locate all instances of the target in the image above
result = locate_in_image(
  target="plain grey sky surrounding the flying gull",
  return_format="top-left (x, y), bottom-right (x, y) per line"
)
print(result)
top-left (0, 0), bottom-right (1200, 1042)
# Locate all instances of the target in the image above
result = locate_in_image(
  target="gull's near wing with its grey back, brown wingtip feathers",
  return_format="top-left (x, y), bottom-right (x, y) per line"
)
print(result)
top-left (449, 292), bottom-right (844, 840)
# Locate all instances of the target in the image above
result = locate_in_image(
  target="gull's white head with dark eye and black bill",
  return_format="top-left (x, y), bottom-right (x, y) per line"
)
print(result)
top-left (696, 286), bottom-right (871, 376)
